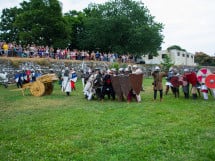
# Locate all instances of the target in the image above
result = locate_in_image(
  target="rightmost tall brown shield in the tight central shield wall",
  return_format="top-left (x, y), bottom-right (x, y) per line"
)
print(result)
top-left (129, 74), bottom-right (143, 94)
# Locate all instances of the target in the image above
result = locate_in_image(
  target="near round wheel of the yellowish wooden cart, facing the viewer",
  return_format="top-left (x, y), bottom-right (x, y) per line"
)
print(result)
top-left (30, 81), bottom-right (45, 97)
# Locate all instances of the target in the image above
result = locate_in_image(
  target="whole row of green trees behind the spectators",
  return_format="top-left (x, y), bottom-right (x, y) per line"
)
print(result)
top-left (0, 0), bottom-right (164, 55)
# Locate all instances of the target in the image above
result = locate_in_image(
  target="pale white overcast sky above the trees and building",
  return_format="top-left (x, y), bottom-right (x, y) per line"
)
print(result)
top-left (0, 0), bottom-right (215, 56)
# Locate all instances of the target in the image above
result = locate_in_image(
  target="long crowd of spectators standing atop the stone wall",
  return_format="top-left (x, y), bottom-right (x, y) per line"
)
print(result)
top-left (0, 42), bottom-right (134, 63)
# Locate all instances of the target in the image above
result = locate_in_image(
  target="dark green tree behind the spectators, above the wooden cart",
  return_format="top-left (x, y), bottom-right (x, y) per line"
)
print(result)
top-left (14, 0), bottom-right (69, 48)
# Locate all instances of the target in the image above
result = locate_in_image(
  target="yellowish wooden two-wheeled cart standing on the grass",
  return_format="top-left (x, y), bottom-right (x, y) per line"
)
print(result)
top-left (19, 74), bottom-right (58, 97)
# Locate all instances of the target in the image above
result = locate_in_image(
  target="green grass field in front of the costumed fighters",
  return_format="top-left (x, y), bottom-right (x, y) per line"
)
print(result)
top-left (0, 79), bottom-right (215, 161)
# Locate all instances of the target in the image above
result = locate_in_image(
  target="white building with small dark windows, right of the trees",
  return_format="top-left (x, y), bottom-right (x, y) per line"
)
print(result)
top-left (143, 49), bottom-right (196, 66)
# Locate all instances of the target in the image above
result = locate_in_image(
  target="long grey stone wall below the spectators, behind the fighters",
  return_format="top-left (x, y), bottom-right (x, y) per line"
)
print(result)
top-left (0, 58), bottom-right (215, 83)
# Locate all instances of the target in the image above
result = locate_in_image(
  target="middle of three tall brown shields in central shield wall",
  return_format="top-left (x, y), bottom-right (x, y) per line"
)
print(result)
top-left (119, 75), bottom-right (132, 98)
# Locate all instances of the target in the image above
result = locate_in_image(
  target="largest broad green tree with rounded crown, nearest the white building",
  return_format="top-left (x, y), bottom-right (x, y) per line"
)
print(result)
top-left (78, 0), bottom-right (163, 55)
